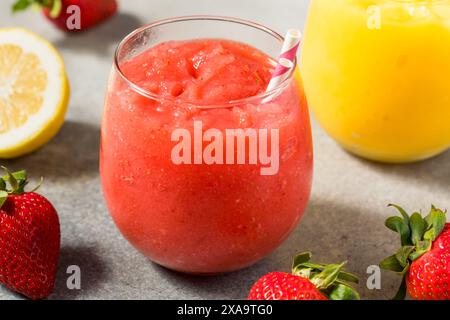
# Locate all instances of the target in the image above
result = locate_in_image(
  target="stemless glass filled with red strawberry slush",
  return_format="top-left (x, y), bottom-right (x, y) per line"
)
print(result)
top-left (100, 17), bottom-right (313, 274)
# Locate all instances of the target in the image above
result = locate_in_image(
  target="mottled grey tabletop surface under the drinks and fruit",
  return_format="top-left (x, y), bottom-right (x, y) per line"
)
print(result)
top-left (0, 0), bottom-right (450, 299)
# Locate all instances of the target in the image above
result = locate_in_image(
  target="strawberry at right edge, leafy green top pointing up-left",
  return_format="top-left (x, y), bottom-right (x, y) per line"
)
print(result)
top-left (380, 205), bottom-right (450, 300)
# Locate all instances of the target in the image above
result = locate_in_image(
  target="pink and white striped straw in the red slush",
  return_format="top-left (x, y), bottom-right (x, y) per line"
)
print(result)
top-left (266, 29), bottom-right (302, 92)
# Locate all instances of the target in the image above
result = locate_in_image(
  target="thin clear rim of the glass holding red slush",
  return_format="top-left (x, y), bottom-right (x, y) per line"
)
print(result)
top-left (114, 15), bottom-right (298, 108)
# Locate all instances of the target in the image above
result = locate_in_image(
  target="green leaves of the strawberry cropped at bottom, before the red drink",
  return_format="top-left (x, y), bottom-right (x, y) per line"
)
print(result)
top-left (292, 252), bottom-right (360, 300)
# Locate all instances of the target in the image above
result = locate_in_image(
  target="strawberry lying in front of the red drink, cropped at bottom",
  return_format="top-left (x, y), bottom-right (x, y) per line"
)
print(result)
top-left (248, 252), bottom-right (359, 300)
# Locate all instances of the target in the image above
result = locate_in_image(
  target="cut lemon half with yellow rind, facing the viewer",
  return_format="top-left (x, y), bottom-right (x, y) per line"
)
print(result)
top-left (0, 28), bottom-right (70, 158)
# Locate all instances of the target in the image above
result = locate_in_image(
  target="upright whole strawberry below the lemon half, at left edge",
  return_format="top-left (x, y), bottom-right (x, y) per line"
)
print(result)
top-left (0, 168), bottom-right (60, 299)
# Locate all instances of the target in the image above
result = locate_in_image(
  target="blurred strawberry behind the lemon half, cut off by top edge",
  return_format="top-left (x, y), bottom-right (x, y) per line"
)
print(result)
top-left (13, 0), bottom-right (118, 32)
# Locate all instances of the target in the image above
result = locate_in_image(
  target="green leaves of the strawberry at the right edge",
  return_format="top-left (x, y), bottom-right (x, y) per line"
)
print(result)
top-left (380, 204), bottom-right (446, 300)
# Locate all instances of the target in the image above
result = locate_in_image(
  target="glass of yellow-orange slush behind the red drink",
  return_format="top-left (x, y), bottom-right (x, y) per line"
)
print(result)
top-left (301, 0), bottom-right (450, 163)
